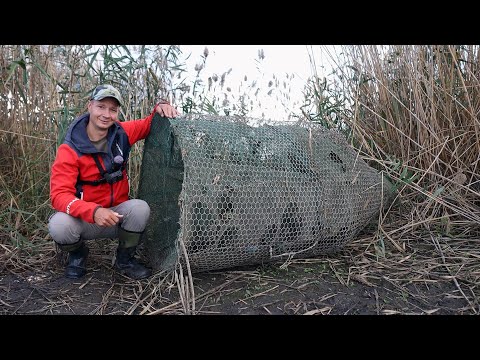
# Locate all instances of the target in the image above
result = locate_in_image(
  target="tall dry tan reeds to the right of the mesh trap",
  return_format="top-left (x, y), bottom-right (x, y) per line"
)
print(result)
top-left (328, 46), bottom-right (480, 313)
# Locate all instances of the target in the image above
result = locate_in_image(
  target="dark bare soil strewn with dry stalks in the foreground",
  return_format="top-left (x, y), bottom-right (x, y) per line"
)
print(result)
top-left (0, 239), bottom-right (475, 315)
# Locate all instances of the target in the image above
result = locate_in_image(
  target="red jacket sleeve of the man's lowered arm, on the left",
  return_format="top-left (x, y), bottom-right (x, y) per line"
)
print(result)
top-left (50, 144), bottom-right (101, 223)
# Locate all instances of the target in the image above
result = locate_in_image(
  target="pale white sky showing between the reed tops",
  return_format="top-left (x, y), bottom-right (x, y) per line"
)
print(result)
top-left (177, 45), bottom-right (338, 121)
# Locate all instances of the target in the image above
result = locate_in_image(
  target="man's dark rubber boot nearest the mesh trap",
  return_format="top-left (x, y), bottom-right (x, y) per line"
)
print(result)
top-left (115, 228), bottom-right (152, 280)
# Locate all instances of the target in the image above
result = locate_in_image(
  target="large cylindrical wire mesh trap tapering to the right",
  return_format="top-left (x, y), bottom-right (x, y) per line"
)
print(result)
top-left (139, 115), bottom-right (392, 272)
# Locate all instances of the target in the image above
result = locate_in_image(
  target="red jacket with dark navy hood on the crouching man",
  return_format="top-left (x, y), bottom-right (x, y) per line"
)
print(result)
top-left (50, 110), bottom-right (155, 223)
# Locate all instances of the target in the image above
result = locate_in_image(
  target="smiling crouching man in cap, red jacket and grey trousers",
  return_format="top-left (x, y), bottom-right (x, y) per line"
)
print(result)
top-left (48, 85), bottom-right (178, 279)
